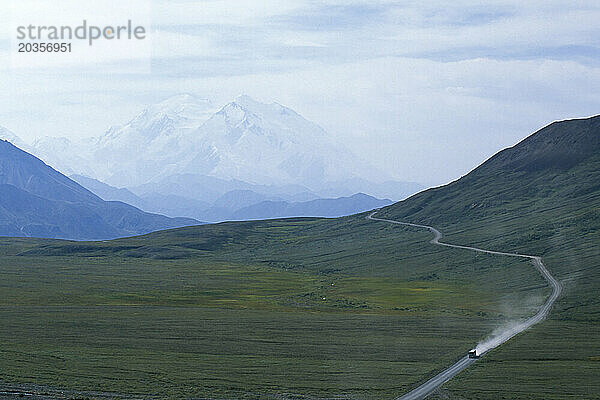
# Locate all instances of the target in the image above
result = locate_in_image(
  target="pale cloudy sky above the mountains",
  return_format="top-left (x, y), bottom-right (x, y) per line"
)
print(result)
top-left (0, 0), bottom-right (600, 185)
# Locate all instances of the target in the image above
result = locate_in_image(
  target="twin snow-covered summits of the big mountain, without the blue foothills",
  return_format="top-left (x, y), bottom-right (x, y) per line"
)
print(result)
top-left (94, 95), bottom-right (384, 189)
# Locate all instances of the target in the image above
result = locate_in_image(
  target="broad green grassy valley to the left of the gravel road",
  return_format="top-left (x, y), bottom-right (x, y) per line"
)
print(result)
top-left (0, 216), bottom-right (546, 399)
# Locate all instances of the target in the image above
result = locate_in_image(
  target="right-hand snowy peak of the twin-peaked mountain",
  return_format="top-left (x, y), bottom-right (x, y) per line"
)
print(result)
top-left (179, 96), bottom-right (382, 189)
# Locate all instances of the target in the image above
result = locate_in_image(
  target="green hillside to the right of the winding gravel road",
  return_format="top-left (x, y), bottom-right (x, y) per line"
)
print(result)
top-left (382, 117), bottom-right (600, 399)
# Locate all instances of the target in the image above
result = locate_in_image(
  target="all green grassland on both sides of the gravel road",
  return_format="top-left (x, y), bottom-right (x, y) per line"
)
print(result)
top-left (0, 118), bottom-right (600, 399)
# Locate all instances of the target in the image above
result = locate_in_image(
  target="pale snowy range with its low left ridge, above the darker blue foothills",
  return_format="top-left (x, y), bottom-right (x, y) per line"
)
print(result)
top-left (0, 94), bottom-right (423, 202)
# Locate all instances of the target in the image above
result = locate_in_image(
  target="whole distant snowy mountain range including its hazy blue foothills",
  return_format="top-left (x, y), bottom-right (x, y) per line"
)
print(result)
top-left (0, 94), bottom-right (423, 222)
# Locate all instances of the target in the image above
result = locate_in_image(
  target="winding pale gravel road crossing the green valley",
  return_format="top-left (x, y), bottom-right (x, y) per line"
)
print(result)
top-left (367, 210), bottom-right (562, 400)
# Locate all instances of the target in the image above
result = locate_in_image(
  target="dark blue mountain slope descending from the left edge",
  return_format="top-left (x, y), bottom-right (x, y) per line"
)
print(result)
top-left (0, 140), bottom-right (199, 240)
